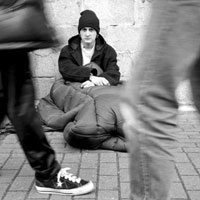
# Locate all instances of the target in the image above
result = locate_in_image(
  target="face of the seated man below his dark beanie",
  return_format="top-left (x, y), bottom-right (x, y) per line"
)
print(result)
top-left (80, 27), bottom-right (97, 45)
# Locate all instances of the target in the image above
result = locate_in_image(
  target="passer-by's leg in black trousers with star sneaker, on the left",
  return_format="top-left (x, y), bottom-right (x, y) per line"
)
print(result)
top-left (0, 50), bottom-right (94, 195)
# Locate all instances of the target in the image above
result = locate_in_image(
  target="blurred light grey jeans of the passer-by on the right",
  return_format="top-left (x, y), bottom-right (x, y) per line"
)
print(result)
top-left (121, 0), bottom-right (200, 200)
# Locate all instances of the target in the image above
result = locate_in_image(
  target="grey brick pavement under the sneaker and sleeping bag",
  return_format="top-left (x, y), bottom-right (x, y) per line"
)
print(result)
top-left (0, 112), bottom-right (200, 200)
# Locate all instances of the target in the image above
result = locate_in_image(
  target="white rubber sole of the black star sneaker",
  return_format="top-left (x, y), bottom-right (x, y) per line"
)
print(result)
top-left (35, 181), bottom-right (94, 196)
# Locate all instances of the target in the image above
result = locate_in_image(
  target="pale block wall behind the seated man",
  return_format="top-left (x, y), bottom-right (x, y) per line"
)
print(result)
top-left (31, 0), bottom-right (192, 111)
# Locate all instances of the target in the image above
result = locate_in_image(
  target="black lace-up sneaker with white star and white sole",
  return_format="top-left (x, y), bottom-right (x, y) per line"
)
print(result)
top-left (35, 168), bottom-right (94, 195)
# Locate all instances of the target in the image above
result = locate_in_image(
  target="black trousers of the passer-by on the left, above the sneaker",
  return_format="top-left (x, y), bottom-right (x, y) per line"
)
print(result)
top-left (0, 50), bottom-right (60, 179)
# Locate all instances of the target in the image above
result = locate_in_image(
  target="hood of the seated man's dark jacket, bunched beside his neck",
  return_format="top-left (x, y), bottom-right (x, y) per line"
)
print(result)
top-left (68, 34), bottom-right (106, 50)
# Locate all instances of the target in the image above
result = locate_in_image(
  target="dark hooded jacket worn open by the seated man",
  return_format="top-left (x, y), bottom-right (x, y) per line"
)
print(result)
top-left (58, 35), bottom-right (120, 85)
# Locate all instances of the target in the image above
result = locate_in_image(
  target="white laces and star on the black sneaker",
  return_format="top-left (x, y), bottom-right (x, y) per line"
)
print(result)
top-left (57, 167), bottom-right (81, 186)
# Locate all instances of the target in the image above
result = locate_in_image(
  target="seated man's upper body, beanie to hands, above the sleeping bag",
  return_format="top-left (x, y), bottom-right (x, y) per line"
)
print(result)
top-left (59, 10), bottom-right (120, 88)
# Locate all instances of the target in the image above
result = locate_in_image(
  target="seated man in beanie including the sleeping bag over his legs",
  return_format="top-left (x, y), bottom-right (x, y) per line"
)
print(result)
top-left (38, 10), bottom-right (127, 151)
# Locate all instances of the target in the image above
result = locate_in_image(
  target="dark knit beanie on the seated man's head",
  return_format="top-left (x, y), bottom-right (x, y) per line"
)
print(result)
top-left (78, 10), bottom-right (100, 34)
